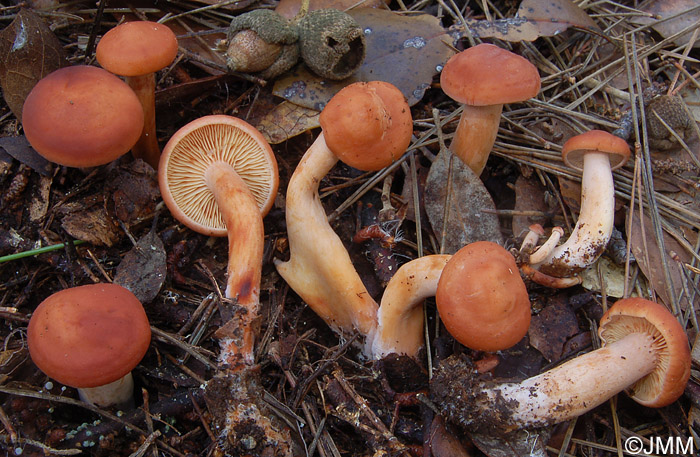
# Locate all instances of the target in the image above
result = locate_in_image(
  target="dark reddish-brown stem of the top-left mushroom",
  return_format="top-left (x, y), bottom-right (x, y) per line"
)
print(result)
top-left (126, 73), bottom-right (160, 170)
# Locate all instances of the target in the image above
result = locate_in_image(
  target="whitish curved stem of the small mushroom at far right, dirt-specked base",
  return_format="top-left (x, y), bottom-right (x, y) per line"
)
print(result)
top-left (531, 152), bottom-right (615, 278)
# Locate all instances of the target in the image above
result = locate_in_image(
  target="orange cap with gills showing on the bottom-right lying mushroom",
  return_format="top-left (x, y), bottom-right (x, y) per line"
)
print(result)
top-left (598, 297), bottom-right (690, 408)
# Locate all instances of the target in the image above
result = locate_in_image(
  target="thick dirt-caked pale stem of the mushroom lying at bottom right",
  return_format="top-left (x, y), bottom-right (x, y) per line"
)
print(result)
top-left (432, 333), bottom-right (659, 433)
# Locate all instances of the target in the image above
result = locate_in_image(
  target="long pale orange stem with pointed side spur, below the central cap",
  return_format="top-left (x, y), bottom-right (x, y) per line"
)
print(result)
top-left (275, 133), bottom-right (377, 348)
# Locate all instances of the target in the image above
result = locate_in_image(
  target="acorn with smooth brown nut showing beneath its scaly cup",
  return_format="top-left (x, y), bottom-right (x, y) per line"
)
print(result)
top-left (226, 9), bottom-right (299, 79)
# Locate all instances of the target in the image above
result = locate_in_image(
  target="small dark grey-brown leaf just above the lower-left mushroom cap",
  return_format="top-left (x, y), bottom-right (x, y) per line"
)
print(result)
top-left (114, 230), bottom-right (167, 303)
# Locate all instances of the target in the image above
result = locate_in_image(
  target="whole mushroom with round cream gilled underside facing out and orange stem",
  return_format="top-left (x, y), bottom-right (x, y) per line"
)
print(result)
top-left (158, 115), bottom-right (278, 367)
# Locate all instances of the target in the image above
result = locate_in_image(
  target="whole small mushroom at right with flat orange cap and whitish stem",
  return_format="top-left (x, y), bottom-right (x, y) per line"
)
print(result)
top-left (529, 130), bottom-right (630, 287)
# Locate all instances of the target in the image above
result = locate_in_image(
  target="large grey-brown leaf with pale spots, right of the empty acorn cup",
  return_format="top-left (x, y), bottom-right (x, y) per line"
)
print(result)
top-left (273, 8), bottom-right (454, 111)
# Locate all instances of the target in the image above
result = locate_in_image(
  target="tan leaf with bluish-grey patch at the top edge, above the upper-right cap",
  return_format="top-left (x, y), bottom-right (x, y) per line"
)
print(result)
top-left (467, 0), bottom-right (600, 41)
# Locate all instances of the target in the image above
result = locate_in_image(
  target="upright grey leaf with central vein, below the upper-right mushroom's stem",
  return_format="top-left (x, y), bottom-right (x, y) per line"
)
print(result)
top-left (424, 150), bottom-right (503, 254)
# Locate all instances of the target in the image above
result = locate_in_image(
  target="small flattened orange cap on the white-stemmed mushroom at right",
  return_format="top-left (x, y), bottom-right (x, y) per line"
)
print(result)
top-left (561, 130), bottom-right (632, 170)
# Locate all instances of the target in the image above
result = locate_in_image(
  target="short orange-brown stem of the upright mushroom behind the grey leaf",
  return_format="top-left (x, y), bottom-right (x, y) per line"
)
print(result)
top-left (450, 104), bottom-right (503, 176)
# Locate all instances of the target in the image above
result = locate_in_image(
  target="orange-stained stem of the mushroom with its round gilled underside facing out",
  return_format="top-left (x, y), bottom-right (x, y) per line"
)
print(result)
top-left (205, 162), bottom-right (265, 367)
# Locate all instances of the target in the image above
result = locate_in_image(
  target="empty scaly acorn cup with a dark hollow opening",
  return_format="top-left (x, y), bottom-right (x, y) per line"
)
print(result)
top-left (298, 8), bottom-right (365, 80)
